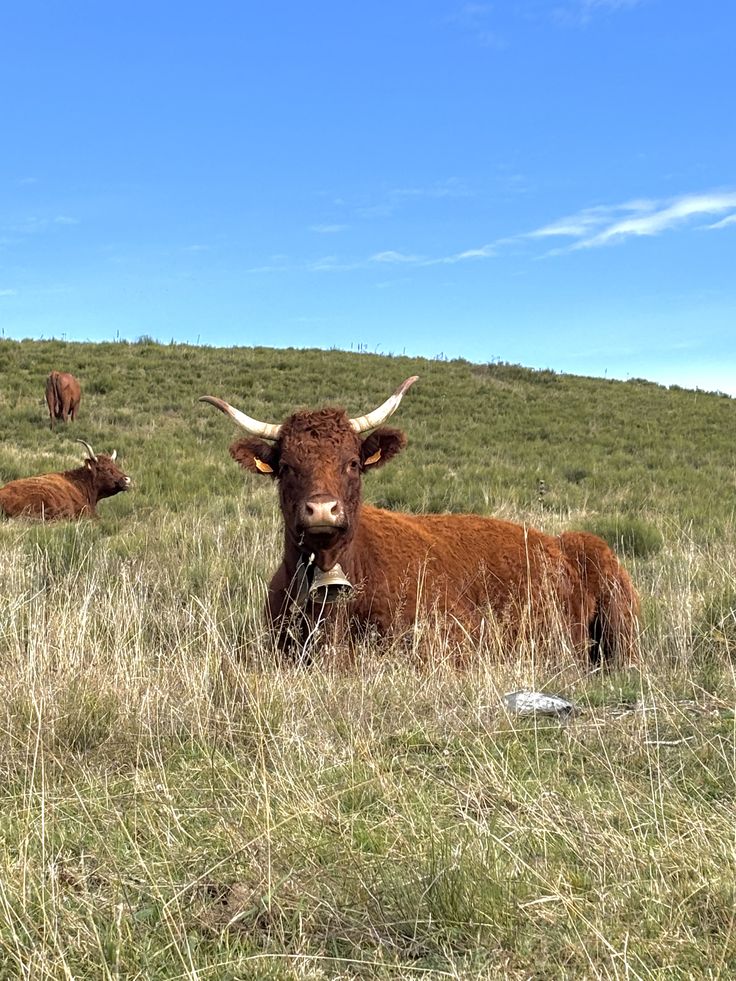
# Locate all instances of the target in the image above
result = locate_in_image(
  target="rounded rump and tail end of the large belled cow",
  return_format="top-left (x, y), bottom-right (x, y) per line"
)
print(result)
top-left (560, 532), bottom-right (639, 666)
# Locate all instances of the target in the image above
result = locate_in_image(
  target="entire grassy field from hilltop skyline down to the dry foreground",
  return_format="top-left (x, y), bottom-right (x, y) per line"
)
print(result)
top-left (0, 341), bottom-right (736, 981)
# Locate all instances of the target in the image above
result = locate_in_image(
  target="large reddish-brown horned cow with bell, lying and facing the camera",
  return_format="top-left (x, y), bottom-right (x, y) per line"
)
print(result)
top-left (201, 377), bottom-right (638, 664)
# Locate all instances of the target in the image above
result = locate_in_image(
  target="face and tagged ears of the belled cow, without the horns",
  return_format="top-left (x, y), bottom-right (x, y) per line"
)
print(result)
top-left (230, 409), bottom-right (406, 553)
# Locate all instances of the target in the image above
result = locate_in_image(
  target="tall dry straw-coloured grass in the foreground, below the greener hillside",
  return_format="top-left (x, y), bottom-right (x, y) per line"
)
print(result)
top-left (0, 506), bottom-right (736, 978)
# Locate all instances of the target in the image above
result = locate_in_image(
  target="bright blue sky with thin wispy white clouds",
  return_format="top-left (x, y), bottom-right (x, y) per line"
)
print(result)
top-left (0, 0), bottom-right (736, 394)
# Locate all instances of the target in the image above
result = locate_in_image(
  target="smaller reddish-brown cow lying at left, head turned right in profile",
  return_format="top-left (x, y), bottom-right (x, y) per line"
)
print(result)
top-left (0, 439), bottom-right (130, 521)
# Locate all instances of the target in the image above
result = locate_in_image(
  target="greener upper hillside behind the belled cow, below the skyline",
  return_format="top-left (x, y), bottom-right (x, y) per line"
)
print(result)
top-left (0, 341), bottom-right (736, 532)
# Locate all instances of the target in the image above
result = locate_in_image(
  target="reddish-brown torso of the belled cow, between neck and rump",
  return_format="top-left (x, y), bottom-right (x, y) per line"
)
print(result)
top-left (350, 506), bottom-right (591, 643)
